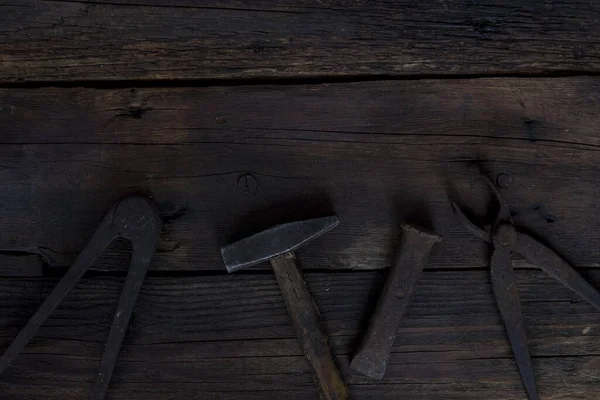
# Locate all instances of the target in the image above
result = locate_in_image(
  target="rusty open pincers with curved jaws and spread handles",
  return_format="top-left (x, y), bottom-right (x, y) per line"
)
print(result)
top-left (452, 177), bottom-right (600, 400)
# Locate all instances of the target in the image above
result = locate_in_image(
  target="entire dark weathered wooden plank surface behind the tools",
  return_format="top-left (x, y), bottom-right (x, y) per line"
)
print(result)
top-left (0, 0), bottom-right (600, 400)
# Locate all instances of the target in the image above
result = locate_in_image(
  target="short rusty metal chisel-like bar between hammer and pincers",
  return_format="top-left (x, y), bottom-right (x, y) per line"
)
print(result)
top-left (350, 225), bottom-right (442, 379)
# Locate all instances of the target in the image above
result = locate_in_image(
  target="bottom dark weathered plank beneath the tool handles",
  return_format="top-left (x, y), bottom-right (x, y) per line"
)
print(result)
top-left (0, 270), bottom-right (600, 400)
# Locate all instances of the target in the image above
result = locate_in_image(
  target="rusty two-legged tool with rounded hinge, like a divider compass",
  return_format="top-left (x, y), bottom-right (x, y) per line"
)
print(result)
top-left (0, 197), bottom-right (161, 400)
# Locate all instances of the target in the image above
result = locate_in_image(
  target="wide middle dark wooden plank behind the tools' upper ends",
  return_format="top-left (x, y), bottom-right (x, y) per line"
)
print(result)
top-left (0, 77), bottom-right (600, 271)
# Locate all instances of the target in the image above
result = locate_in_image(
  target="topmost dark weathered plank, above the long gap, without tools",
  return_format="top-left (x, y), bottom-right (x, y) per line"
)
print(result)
top-left (0, 0), bottom-right (600, 82)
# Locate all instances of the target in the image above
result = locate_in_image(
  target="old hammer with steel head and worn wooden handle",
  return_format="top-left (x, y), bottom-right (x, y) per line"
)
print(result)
top-left (221, 217), bottom-right (348, 400)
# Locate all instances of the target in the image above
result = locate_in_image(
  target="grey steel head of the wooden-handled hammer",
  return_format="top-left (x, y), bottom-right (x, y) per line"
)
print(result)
top-left (221, 216), bottom-right (340, 273)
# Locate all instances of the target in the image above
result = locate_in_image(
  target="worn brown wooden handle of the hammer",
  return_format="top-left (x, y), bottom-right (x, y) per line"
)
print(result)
top-left (270, 252), bottom-right (349, 400)
